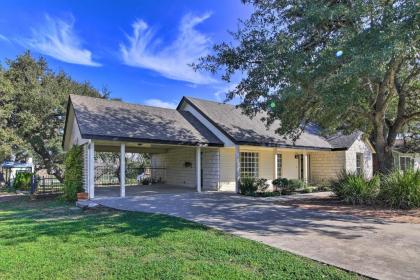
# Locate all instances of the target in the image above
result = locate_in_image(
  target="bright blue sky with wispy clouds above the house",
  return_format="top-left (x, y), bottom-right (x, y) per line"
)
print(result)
top-left (0, 0), bottom-right (251, 107)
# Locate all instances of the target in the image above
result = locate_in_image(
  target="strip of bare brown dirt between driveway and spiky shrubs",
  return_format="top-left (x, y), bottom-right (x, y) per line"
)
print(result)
top-left (276, 197), bottom-right (420, 224)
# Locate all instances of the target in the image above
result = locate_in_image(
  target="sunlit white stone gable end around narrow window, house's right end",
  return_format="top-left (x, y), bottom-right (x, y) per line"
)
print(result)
top-left (345, 139), bottom-right (373, 178)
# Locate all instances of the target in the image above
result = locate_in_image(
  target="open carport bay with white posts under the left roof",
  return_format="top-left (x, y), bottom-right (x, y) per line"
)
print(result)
top-left (84, 140), bottom-right (217, 199)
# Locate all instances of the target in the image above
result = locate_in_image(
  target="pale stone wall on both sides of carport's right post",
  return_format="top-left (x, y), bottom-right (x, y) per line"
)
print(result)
top-left (152, 147), bottom-right (219, 190)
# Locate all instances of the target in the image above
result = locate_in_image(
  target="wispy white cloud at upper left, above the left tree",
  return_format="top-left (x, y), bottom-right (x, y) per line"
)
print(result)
top-left (18, 15), bottom-right (101, 66)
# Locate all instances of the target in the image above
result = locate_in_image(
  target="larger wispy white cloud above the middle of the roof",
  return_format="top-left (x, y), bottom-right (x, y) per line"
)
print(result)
top-left (120, 13), bottom-right (215, 84)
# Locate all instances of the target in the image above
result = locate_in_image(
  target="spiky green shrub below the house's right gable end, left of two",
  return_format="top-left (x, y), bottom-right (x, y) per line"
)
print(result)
top-left (332, 172), bottom-right (380, 204)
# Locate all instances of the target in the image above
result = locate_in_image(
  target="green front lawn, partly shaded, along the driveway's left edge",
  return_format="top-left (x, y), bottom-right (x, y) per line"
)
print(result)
top-left (0, 198), bottom-right (357, 279)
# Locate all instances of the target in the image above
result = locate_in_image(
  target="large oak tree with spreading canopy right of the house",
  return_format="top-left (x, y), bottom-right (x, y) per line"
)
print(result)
top-left (195, 0), bottom-right (420, 173)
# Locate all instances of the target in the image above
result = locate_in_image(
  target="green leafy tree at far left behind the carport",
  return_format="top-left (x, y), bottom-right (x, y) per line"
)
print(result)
top-left (0, 52), bottom-right (108, 181)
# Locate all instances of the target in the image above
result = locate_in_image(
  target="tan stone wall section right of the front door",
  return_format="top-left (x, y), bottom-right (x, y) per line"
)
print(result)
top-left (310, 151), bottom-right (346, 184)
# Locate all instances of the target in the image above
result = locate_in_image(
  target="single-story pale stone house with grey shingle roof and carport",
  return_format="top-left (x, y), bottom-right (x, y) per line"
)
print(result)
top-left (63, 95), bottom-right (374, 198)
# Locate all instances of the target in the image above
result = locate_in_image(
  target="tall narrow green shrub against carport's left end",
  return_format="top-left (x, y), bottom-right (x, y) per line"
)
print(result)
top-left (64, 146), bottom-right (83, 201)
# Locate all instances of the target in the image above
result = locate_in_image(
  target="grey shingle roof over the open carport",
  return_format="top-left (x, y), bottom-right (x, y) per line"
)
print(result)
top-left (70, 95), bottom-right (223, 146)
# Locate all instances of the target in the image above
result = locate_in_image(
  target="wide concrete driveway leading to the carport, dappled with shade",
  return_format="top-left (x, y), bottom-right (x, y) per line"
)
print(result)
top-left (96, 192), bottom-right (420, 279)
